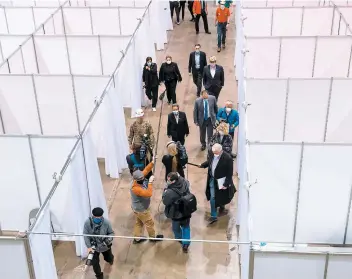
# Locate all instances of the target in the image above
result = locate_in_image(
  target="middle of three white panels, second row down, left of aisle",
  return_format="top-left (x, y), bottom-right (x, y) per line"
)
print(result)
top-left (67, 37), bottom-right (102, 75)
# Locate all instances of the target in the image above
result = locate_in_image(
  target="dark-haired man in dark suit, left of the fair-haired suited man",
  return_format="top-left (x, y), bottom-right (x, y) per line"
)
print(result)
top-left (188, 44), bottom-right (207, 97)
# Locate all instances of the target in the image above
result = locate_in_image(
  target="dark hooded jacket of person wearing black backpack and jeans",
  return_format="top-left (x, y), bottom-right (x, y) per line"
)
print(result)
top-left (163, 176), bottom-right (191, 221)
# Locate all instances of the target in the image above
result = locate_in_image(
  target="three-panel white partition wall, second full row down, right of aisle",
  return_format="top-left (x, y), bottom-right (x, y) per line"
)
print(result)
top-left (245, 36), bottom-right (352, 78)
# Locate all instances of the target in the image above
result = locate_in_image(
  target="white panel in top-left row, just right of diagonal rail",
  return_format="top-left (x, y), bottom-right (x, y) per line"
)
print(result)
top-left (63, 8), bottom-right (94, 35)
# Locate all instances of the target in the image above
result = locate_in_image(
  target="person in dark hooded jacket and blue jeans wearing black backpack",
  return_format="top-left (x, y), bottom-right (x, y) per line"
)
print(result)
top-left (162, 172), bottom-right (197, 253)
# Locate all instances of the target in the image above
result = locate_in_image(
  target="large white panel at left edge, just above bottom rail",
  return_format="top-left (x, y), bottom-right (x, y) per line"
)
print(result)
top-left (0, 137), bottom-right (39, 232)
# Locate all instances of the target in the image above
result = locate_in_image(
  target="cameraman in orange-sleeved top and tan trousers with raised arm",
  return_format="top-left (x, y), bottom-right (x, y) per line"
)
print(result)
top-left (130, 158), bottom-right (164, 244)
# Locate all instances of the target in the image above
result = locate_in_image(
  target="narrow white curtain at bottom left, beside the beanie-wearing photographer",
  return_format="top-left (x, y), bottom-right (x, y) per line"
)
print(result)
top-left (29, 202), bottom-right (58, 279)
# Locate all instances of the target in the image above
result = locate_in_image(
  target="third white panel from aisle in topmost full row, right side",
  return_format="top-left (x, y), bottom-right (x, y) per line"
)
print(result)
top-left (302, 7), bottom-right (336, 36)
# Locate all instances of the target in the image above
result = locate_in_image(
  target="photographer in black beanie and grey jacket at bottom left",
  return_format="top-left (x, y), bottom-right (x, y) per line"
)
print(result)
top-left (83, 207), bottom-right (114, 279)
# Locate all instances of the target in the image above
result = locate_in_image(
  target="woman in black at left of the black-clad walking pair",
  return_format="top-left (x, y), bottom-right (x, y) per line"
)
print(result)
top-left (142, 57), bottom-right (159, 111)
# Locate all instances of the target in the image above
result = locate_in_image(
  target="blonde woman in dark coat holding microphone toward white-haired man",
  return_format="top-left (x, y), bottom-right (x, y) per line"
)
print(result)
top-left (162, 141), bottom-right (188, 181)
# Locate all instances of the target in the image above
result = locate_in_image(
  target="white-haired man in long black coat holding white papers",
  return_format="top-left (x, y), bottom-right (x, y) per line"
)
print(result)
top-left (199, 143), bottom-right (236, 225)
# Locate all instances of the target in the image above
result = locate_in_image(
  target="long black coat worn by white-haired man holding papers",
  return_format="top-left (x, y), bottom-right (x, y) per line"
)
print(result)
top-left (201, 152), bottom-right (236, 207)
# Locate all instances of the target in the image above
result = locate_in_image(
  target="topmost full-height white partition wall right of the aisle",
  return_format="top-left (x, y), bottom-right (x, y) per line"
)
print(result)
top-left (242, 7), bottom-right (352, 36)
